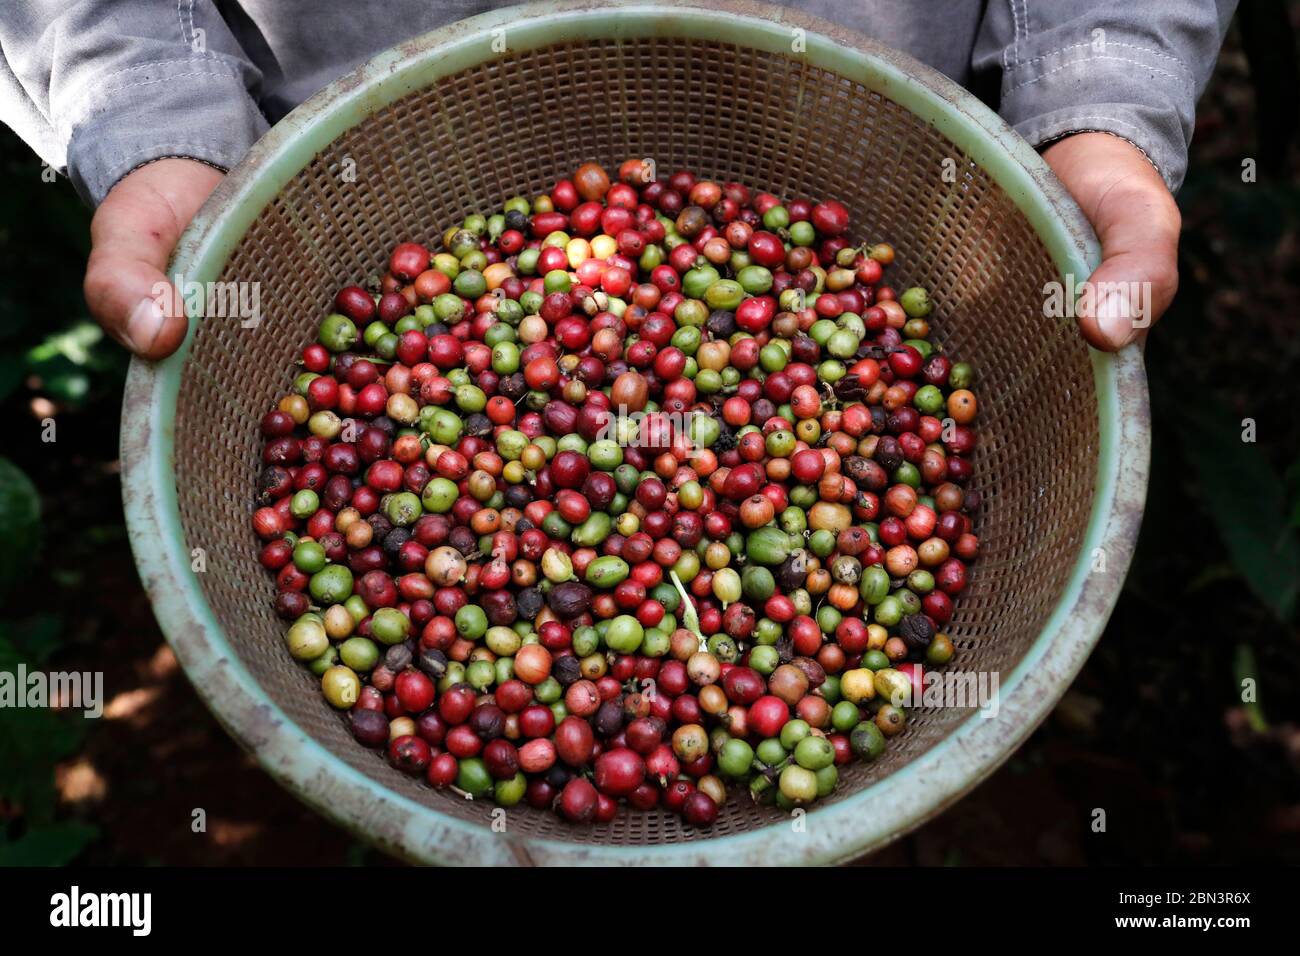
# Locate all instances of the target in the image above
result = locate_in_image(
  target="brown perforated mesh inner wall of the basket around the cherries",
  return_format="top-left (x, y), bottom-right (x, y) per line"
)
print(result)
top-left (129, 1), bottom-right (1138, 858)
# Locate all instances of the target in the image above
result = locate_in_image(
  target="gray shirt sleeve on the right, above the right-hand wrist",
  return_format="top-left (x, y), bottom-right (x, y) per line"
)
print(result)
top-left (972, 0), bottom-right (1236, 190)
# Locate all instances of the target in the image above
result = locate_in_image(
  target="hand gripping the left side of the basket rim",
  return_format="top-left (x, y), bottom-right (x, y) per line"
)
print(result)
top-left (83, 159), bottom-right (222, 360)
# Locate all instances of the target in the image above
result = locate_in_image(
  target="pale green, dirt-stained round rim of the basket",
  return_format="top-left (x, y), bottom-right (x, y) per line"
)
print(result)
top-left (121, 0), bottom-right (1151, 865)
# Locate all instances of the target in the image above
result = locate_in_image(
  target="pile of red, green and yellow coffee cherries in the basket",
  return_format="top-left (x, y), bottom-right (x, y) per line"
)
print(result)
top-left (252, 160), bottom-right (979, 826)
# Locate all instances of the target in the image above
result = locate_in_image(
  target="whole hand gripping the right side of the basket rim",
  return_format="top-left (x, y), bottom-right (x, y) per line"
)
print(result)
top-left (1043, 133), bottom-right (1183, 351)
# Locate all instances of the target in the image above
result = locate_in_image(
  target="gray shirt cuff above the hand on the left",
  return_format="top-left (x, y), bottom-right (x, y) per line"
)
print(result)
top-left (68, 59), bottom-right (267, 206)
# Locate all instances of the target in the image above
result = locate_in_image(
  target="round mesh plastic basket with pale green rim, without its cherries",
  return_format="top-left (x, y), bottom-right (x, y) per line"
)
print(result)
top-left (122, 0), bottom-right (1149, 865)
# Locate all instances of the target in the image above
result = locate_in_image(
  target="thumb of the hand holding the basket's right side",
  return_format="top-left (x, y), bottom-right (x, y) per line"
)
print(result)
top-left (1078, 193), bottom-right (1179, 351)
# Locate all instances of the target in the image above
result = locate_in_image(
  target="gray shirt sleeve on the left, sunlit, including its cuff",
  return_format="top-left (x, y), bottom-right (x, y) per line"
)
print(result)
top-left (0, 0), bottom-right (267, 203)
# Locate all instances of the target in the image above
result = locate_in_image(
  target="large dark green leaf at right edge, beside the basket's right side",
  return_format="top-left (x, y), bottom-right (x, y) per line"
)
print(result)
top-left (1179, 408), bottom-right (1300, 620)
